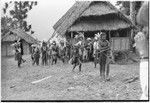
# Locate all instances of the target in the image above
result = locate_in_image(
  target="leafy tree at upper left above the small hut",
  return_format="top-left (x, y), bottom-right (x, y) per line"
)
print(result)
top-left (3, 1), bottom-right (37, 33)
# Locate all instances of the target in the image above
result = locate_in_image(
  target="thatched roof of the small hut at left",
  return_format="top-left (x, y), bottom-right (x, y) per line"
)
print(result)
top-left (2, 29), bottom-right (37, 44)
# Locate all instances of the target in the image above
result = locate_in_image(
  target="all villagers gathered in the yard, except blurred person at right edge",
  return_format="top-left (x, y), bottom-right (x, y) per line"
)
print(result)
top-left (13, 32), bottom-right (113, 80)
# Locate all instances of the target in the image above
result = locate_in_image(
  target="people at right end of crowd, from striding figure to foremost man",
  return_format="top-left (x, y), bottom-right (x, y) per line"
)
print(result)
top-left (70, 32), bottom-right (113, 80)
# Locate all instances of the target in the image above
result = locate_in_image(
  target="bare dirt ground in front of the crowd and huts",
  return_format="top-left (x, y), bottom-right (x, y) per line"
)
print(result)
top-left (1, 56), bottom-right (141, 100)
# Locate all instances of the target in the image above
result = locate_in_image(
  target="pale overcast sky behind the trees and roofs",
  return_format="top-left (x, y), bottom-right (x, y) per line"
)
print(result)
top-left (2, 0), bottom-right (115, 40)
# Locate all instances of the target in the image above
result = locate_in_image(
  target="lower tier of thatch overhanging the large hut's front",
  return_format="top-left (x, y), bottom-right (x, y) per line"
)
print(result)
top-left (68, 15), bottom-right (131, 31)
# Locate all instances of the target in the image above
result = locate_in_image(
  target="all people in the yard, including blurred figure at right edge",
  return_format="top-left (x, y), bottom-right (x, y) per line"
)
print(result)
top-left (10, 3), bottom-right (149, 99)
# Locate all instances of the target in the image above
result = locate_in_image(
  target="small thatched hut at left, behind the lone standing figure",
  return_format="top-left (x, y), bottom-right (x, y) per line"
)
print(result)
top-left (1, 29), bottom-right (37, 56)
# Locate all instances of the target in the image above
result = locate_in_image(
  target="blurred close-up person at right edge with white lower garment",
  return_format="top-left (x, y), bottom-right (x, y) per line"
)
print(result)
top-left (134, 2), bottom-right (149, 100)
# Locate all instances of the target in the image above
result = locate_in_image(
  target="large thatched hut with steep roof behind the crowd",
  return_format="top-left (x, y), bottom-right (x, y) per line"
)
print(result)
top-left (53, 1), bottom-right (134, 51)
